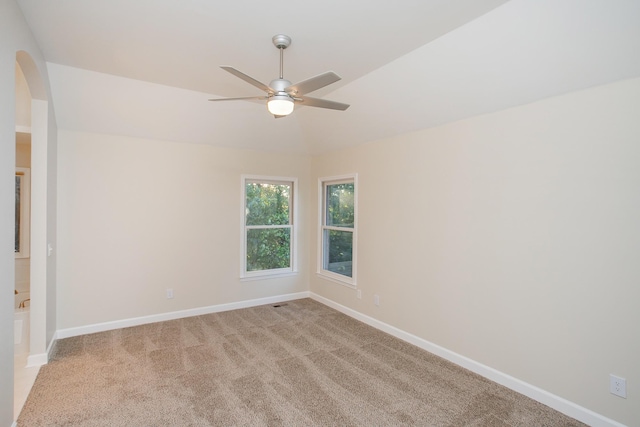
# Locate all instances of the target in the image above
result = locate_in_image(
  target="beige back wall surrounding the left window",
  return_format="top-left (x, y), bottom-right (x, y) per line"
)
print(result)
top-left (58, 131), bottom-right (310, 329)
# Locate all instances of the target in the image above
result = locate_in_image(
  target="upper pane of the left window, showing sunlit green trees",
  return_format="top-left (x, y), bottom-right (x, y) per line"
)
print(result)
top-left (245, 182), bottom-right (291, 225)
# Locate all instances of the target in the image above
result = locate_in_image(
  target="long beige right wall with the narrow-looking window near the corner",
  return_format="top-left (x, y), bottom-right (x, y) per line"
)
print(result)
top-left (310, 79), bottom-right (640, 425)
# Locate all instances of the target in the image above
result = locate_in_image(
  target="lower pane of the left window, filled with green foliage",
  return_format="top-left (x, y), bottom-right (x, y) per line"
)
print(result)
top-left (247, 228), bottom-right (291, 271)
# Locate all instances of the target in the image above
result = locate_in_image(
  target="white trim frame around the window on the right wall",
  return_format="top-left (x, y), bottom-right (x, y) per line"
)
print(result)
top-left (316, 173), bottom-right (358, 289)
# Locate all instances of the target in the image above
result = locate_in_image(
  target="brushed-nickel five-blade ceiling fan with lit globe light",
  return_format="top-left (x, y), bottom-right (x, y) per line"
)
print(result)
top-left (209, 34), bottom-right (349, 118)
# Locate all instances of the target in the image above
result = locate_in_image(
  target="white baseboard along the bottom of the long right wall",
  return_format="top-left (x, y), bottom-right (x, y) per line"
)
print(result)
top-left (309, 293), bottom-right (625, 427)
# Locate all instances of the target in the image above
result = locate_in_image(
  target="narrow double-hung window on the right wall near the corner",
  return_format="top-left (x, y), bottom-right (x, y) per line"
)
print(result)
top-left (318, 175), bottom-right (357, 287)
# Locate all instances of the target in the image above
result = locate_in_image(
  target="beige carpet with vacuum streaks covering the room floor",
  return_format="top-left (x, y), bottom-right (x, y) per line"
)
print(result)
top-left (18, 299), bottom-right (583, 427)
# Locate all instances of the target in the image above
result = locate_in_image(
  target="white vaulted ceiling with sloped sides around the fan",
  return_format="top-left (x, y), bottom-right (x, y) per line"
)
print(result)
top-left (13, 0), bottom-right (640, 153)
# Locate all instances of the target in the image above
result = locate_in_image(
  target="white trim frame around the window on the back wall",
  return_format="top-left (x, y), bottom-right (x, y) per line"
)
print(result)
top-left (240, 175), bottom-right (298, 281)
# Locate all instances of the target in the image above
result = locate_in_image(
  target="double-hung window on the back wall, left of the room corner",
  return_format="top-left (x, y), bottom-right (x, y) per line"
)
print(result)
top-left (241, 176), bottom-right (297, 278)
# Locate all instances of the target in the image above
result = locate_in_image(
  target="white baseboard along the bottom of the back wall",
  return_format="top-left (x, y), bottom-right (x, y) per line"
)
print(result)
top-left (55, 292), bottom-right (310, 342)
